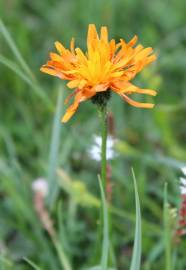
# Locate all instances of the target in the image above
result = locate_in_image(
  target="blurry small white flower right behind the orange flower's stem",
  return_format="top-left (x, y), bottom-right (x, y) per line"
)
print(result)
top-left (88, 136), bottom-right (116, 161)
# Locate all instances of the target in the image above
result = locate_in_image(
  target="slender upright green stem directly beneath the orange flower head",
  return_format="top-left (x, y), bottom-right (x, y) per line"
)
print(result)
top-left (100, 106), bottom-right (107, 193)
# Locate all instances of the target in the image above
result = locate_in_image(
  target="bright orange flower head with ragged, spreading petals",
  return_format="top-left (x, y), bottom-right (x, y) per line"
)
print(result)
top-left (41, 24), bottom-right (156, 122)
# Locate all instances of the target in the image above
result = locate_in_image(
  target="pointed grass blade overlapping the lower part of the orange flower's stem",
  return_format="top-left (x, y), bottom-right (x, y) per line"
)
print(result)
top-left (98, 176), bottom-right (109, 270)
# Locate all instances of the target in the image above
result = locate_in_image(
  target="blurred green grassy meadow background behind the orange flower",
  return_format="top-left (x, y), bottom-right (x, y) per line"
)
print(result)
top-left (0, 0), bottom-right (186, 270)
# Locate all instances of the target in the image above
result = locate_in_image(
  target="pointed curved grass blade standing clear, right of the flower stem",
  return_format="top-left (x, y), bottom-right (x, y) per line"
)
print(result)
top-left (130, 169), bottom-right (141, 270)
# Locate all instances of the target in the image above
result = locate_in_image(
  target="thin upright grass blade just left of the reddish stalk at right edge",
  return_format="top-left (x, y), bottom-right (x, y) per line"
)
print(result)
top-left (163, 183), bottom-right (173, 270)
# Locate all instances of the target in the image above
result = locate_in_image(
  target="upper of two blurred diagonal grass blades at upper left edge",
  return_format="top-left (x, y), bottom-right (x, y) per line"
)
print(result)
top-left (0, 19), bottom-right (35, 80)
